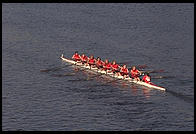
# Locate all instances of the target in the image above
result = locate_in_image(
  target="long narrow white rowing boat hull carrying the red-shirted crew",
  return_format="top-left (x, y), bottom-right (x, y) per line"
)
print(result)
top-left (60, 54), bottom-right (166, 91)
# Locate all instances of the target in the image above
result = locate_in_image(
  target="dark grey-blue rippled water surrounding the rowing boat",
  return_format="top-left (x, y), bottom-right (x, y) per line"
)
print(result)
top-left (2, 3), bottom-right (194, 131)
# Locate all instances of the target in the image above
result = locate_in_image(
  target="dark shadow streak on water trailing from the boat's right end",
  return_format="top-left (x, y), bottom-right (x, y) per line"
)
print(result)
top-left (166, 90), bottom-right (194, 103)
